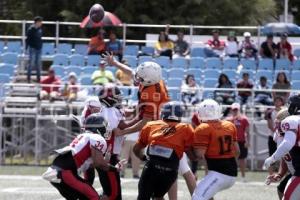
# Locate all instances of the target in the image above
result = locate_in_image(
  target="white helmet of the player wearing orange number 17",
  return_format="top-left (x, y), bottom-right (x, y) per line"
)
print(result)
top-left (198, 99), bottom-right (222, 121)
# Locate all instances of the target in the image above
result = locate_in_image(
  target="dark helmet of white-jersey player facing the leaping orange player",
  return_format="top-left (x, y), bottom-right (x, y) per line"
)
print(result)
top-left (98, 84), bottom-right (122, 107)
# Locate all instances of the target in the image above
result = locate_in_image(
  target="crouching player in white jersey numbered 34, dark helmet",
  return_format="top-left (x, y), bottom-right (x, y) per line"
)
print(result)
top-left (42, 114), bottom-right (124, 200)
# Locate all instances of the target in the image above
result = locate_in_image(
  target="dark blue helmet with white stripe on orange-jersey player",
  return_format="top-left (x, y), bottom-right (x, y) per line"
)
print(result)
top-left (161, 101), bottom-right (183, 121)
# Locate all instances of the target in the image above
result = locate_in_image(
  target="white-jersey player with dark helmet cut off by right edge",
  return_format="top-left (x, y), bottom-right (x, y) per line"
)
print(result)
top-left (264, 95), bottom-right (300, 200)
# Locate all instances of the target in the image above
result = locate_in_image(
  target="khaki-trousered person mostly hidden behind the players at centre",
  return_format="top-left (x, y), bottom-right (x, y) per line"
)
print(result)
top-left (121, 132), bottom-right (141, 179)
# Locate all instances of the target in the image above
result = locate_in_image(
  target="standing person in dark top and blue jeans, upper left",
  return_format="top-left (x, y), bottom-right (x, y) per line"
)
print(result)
top-left (26, 16), bottom-right (43, 83)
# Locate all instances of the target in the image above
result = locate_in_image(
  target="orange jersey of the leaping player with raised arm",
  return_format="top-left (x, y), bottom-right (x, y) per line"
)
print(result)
top-left (138, 81), bottom-right (170, 120)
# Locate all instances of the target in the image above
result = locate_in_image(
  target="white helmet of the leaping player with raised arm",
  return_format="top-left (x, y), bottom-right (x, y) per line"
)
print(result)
top-left (135, 62), bottom-right (162, 86)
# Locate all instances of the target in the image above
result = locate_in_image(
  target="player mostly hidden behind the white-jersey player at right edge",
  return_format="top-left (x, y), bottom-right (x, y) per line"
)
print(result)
top-left (266, 108), bottom-right (295, 199)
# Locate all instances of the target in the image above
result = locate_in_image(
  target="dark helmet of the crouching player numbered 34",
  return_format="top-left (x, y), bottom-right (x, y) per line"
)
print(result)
top-left (83, 113), bottom-right (109, 138)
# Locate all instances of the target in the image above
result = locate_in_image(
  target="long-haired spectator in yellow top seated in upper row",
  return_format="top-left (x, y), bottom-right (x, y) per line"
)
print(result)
top-left (155, 31), bottom-right (174, 59)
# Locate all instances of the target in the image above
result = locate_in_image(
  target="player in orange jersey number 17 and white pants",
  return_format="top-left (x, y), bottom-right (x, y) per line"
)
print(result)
top-left (192, 99), bottom-right (239, 200)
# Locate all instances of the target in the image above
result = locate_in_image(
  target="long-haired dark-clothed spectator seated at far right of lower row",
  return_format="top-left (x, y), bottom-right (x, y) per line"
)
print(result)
top-left (272, 72), bottom-right (291, 102)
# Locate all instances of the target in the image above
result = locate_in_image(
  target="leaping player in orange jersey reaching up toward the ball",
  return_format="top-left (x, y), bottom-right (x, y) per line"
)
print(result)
top-left (105, 55), bottom-right (169, 136)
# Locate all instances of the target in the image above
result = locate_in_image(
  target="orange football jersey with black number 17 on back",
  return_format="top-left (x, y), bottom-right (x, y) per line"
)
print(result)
top-left (194, 120), bottom-right (237, 159)
